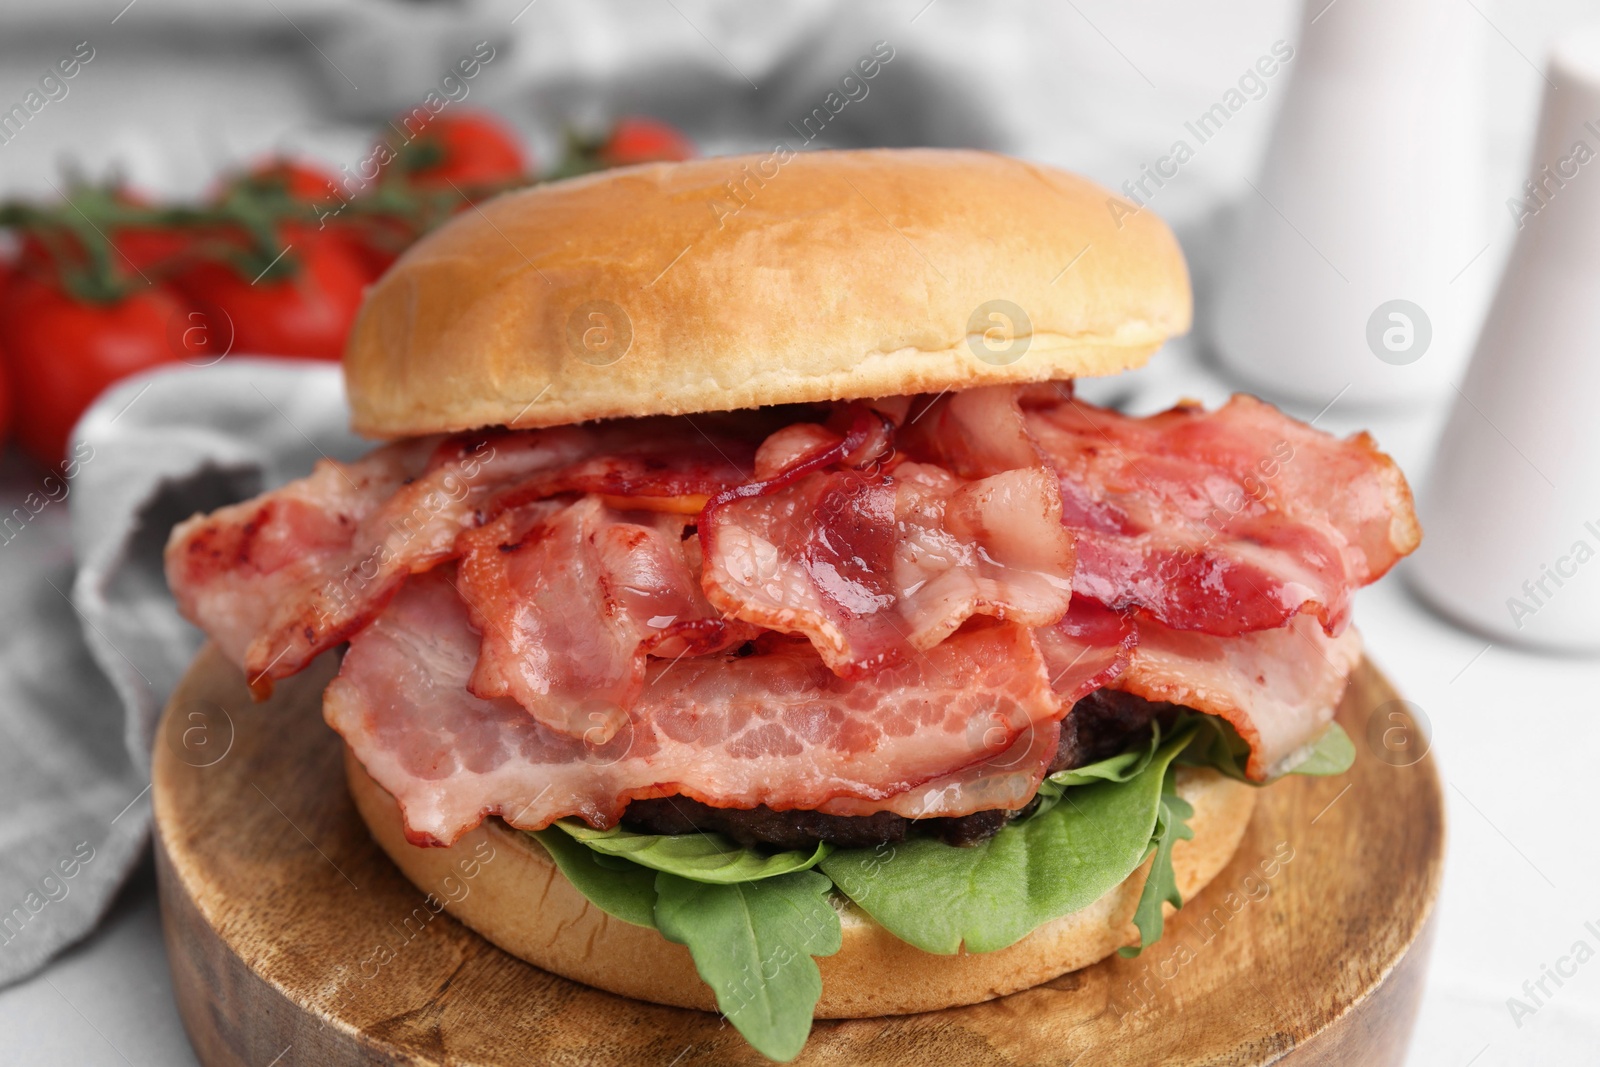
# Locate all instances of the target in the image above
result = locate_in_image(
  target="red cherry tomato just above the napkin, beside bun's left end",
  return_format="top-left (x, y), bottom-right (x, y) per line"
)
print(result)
top-left (173, 227), bottom-right (366, 360)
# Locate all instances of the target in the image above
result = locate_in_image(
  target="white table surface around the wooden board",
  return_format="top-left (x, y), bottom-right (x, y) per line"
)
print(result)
top-left (0, 349), bottom-right (1600, 1067)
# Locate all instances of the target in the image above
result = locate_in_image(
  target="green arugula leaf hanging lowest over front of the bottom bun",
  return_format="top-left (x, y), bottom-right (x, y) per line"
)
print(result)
top-left (656, 870), bottom-right (843, 1061)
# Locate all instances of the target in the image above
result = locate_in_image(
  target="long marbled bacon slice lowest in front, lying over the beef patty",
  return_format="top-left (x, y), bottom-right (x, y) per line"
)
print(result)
top-left (323, 568), bottom-right (1059, 845)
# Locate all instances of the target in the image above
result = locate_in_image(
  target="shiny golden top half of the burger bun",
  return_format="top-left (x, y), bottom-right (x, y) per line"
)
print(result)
top-left (344, 149), bottom-right (1190, 437)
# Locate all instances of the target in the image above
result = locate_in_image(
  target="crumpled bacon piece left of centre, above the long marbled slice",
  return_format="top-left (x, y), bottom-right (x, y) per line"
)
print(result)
top-left (458, 496), bottom-right (757, 742)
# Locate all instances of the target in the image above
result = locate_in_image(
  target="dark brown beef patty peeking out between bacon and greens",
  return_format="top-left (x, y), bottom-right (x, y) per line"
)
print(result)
top-left (622, 689), bottom-right (1178, 849)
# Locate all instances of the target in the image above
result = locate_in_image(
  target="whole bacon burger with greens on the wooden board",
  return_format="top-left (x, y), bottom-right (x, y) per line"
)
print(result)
top-left (166, 150), bottom-right (1419, 1059)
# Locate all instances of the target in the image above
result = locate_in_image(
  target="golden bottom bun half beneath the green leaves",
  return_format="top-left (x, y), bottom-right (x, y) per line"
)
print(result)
top-left (344, 749), bottom-right (1256, 1019)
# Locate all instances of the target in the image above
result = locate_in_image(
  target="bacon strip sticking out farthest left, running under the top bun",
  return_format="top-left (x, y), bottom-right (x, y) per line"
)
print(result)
top-left (166, 419), bottom-right (754, 696)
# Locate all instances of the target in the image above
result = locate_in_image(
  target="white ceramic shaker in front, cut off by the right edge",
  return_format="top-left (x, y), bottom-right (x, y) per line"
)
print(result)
top-left (1410, 27), bottom-right (1600, 651)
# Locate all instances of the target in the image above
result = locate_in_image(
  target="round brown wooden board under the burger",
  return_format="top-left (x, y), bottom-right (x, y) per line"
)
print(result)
top-left (154, 648), bottom-right (1443, 1067)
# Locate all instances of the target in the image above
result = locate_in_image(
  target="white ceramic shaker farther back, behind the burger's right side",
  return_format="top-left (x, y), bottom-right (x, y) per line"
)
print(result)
top-left (1210, 0), bottom-right (1490, 406)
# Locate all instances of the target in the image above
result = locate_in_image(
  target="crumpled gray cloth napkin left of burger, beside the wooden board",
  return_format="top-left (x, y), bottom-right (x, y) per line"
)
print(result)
top-left (0, 357), bottom-right (360, 984)
